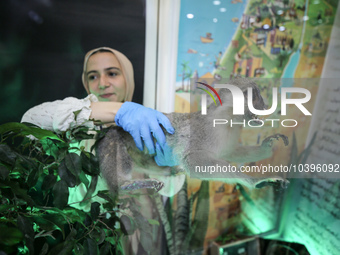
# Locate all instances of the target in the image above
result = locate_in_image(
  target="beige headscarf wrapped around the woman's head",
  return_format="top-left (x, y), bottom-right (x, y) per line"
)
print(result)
top-left (81, 47), bottom-right (135, 102)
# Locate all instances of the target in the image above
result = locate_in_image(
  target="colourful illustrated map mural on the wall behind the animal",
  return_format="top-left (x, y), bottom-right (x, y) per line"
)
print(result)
top-left (175, 0), bottom-right (338, 252)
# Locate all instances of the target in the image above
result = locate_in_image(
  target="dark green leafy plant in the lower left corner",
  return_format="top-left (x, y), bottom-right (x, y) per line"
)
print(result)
top-left (0, 123), bottom-right (126, 255)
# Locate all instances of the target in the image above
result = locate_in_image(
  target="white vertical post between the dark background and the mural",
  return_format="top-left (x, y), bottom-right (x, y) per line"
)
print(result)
top-left (143, 0), bottom-right (180, 112)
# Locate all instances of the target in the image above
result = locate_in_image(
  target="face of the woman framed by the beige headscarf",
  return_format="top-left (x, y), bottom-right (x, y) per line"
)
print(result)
top-left (85, 52), bottom-right (126, 102)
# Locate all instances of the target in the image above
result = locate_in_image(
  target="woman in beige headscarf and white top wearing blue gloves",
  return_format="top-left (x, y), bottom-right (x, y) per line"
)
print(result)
top-left (21, 47), bottom-right (175, 166)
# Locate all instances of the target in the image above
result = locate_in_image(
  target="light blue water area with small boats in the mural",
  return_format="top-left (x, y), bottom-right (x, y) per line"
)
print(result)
top-left (176, 0), bottom-right (247, 82)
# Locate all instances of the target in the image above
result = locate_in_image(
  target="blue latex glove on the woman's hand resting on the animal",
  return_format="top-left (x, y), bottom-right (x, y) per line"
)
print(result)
top-left (115, 102), bottom-right (175, 154)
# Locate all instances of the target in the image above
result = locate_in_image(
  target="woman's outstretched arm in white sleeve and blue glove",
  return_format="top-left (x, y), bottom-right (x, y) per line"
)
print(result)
top-left (21, 94), bottom-right (175, 166)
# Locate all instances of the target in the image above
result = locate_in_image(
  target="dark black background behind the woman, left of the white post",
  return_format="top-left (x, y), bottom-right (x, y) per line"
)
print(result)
top-left (0, 0), bottom-right (145, 124)
